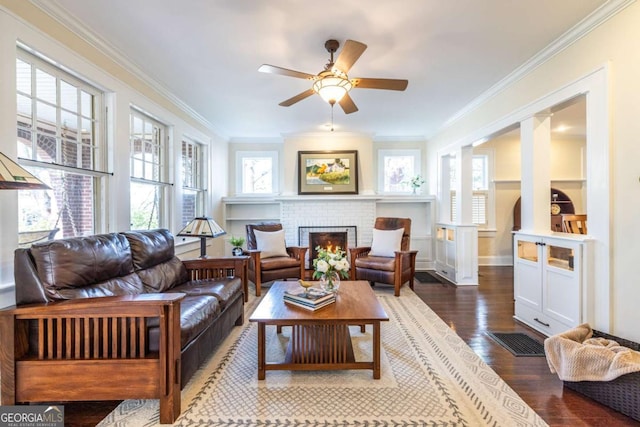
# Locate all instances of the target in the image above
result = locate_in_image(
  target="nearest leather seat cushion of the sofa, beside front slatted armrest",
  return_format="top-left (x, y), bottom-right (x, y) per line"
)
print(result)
top-left (147, 295), bottom-right (221, 351)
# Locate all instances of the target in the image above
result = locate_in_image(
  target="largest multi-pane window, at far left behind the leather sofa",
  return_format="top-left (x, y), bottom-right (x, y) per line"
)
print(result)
top-left (16, 49), bottom-right (107, 247)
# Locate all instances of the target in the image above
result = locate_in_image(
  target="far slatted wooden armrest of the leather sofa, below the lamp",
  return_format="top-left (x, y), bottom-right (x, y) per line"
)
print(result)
top-left (182, 255), bottom-right (249, 302)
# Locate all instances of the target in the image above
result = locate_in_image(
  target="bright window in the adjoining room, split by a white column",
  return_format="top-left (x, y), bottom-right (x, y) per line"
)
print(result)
top-left (449, 154), bottom-right (492, 228)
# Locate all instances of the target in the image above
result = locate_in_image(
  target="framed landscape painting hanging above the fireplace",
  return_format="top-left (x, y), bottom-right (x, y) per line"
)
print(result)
top-left (298, 150), bottom-right (358, 195)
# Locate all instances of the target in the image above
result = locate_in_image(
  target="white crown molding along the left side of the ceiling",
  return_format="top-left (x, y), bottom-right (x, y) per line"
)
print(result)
top-left (29, 0), bottom-right (229, 139)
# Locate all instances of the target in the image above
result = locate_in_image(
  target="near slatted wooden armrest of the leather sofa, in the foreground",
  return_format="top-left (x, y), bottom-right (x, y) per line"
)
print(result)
top-left (0, 293), bottom-right (185, 423)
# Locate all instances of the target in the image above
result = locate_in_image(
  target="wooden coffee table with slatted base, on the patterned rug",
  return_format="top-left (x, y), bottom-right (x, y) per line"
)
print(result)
top-left (249, 280), bottom-right (389, 380)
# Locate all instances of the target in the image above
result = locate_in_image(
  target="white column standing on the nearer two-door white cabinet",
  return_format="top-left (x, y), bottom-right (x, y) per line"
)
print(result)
top-left (520, 114), bottom-right (551, 233)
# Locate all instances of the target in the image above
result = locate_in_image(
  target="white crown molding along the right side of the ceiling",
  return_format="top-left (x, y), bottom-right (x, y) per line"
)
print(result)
top-left (440, 0), bottom-right (636, 136)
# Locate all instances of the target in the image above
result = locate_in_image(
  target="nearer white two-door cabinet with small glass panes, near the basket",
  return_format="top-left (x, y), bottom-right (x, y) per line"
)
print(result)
top-left (513, 233), bottom-right (590, 335)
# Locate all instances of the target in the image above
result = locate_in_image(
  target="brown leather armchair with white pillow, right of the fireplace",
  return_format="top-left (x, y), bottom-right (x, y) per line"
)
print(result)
top-left (349, 217), bottom-right (418, 296)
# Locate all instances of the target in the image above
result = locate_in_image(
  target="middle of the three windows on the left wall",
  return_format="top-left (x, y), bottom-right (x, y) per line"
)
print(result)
top-left (129, 108), bottom-right (171, 230)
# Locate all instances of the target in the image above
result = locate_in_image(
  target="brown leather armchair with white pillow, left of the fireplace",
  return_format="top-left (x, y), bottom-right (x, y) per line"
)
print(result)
top-left (245, 223), bottom-right (307, 296)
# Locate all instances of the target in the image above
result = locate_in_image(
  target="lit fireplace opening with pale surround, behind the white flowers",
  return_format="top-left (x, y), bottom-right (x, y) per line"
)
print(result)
top-left (298, 225), bottom-right (358, 269)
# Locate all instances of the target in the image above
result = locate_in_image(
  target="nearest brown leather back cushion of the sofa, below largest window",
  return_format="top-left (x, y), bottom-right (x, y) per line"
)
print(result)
top-left (29, 233), bottom-right (141, 299)
